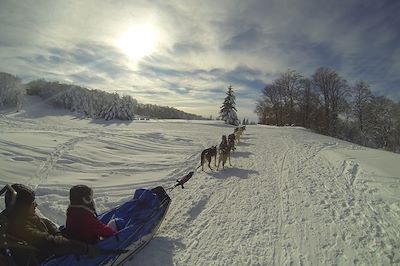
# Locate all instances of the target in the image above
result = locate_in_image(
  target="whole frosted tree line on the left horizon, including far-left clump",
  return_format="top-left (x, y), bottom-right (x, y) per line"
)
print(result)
top-left (0, 73), bottom-right (204, 120)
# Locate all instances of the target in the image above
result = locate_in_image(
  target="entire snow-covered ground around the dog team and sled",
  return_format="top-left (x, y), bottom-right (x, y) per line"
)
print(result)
top-left (0, 98), bottom-right (400, 265)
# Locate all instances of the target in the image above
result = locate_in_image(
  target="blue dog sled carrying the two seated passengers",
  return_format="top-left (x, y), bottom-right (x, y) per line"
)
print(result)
top-left (0, 185), bottom-right (171, 266)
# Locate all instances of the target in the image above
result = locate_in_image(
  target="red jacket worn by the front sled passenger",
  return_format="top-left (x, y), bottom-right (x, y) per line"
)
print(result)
top-left (66, 205), bottom-right (116, 244)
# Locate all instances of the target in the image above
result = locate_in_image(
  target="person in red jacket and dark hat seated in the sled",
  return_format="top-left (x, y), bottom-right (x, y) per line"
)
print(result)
top-left (66, 185), bottom-right (116, 244)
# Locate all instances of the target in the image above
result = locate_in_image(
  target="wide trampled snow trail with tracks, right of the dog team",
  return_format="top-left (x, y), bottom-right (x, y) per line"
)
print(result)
top-left (132, 126), bottom-right (400, 265)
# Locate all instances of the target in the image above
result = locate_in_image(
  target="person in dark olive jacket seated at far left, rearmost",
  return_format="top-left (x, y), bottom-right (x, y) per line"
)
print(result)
top-left (5, 184), bottom-right (97, 265)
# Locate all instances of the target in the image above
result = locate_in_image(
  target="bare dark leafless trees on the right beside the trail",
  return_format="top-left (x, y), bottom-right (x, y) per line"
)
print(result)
top-left (255, 67), bottom-right (400, 152)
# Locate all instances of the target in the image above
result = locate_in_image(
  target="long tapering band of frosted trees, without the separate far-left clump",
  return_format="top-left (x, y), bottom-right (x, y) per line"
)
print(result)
top-left (25, 77), bottom-right (204, 120)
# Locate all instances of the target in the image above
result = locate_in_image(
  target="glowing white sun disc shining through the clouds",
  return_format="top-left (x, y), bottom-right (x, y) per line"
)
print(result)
top-left (118, 25), bottom-right (157, 62)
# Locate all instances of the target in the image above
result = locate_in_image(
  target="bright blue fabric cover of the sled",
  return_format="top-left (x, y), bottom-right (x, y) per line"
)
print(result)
top-left (42, 189), bottom-right (169, 266)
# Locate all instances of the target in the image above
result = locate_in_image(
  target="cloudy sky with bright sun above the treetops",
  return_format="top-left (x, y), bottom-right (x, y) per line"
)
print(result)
top-left (0, 0), bottom-right (400, 121)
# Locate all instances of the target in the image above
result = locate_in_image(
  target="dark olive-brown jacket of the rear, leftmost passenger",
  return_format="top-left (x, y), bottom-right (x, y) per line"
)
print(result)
top-left (7, 214), bottom-right (88, 265)
